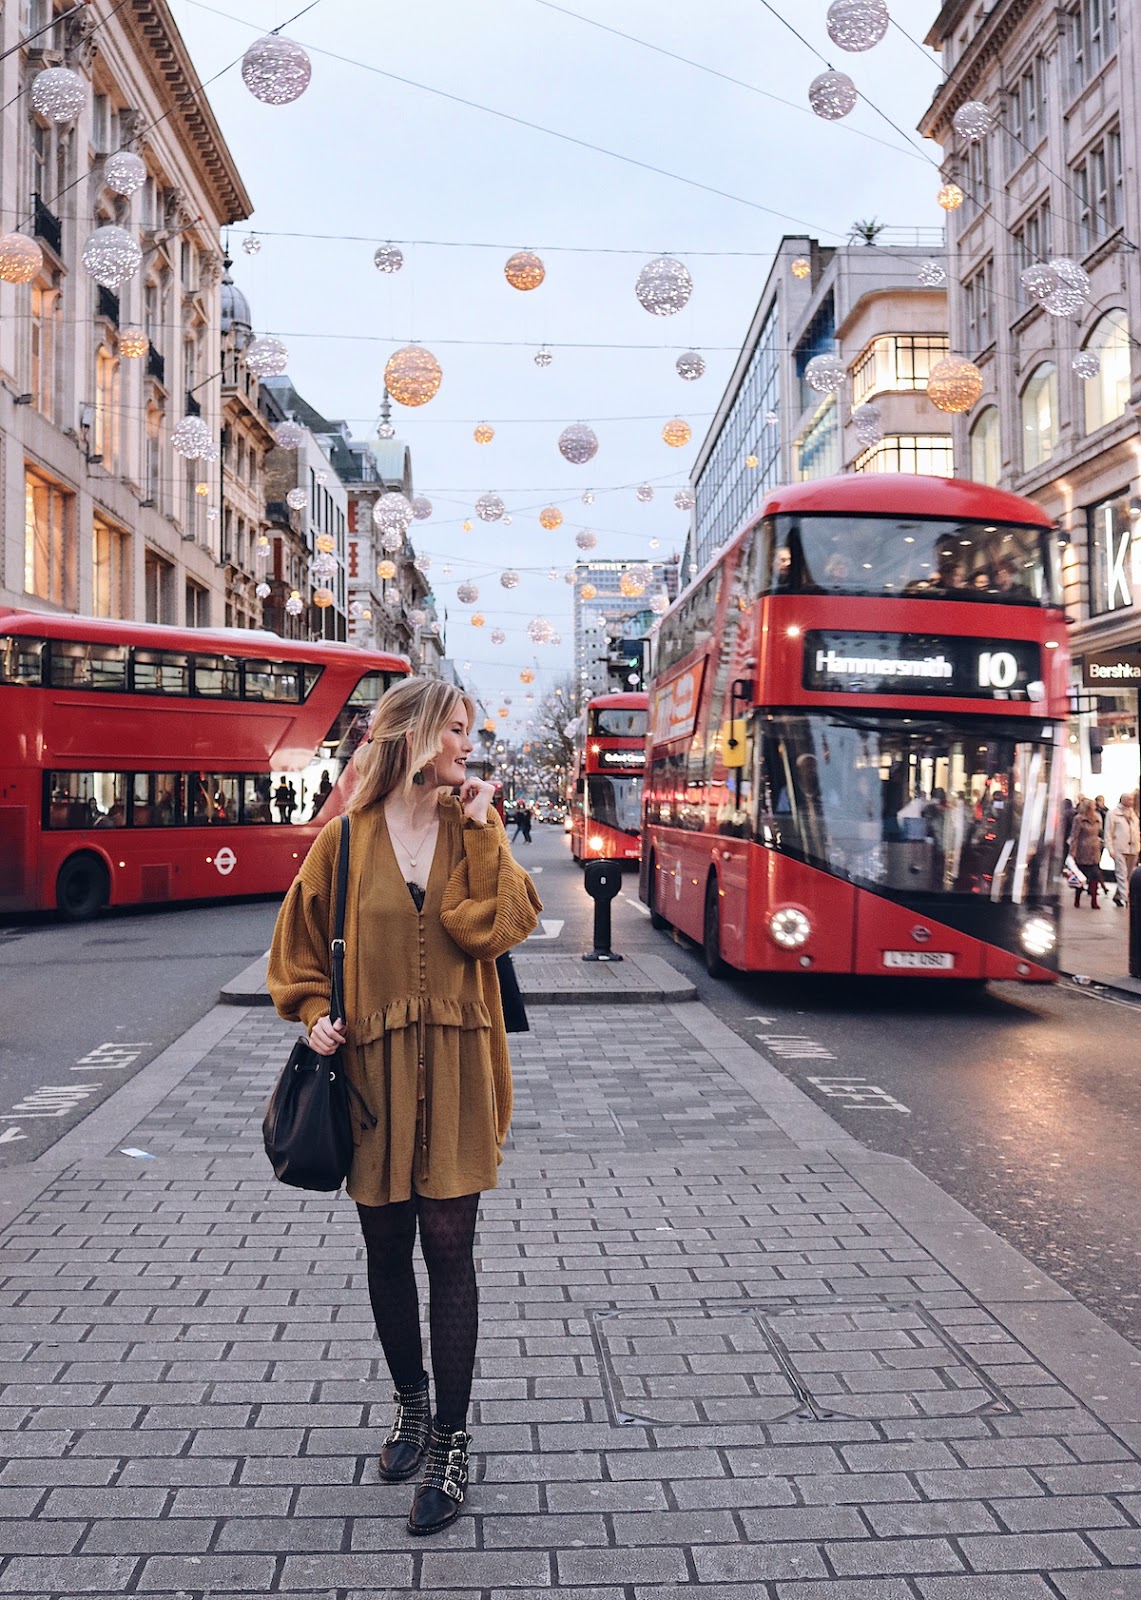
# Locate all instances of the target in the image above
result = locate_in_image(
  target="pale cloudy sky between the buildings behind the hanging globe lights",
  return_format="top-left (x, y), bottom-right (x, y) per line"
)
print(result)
top-left (171, 0), bottom-right (943, 723)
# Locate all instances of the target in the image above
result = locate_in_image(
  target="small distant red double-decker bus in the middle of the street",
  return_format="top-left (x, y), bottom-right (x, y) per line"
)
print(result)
top-left (570, 693), bottom-right (648, 861)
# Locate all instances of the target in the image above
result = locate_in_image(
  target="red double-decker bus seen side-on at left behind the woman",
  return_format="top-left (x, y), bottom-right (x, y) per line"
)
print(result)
top-left (0, 608), bottom-right (408, 920)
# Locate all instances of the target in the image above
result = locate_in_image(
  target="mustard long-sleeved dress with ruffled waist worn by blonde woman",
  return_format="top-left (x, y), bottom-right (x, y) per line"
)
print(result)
top-left (269, 795), bottom-right (542, 1206)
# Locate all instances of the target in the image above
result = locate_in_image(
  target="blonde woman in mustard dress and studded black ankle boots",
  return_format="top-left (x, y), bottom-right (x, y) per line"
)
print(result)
top-left (269, 678), bottom-right (542, 1534)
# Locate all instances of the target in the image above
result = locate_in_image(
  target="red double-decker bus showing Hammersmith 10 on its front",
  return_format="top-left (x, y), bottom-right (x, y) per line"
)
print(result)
top-left (642, 475), bottom-right (1069, 981)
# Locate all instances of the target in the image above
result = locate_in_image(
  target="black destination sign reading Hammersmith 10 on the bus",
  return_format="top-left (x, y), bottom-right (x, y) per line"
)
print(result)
top-left (803, 632), bottom-right (1042, 699)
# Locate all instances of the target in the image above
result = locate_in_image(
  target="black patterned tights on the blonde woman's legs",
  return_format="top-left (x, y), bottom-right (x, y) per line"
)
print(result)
top-left (357, 1194), bottom-right (480, 1432)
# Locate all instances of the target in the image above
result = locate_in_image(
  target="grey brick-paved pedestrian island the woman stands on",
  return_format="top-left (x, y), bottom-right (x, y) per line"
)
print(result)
top-left (0, 1006), bottom-right (1141, 1600)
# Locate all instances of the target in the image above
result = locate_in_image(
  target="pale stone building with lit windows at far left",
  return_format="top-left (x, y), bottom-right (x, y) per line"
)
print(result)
top-left (0, 0), bottom-right (251, 626)
